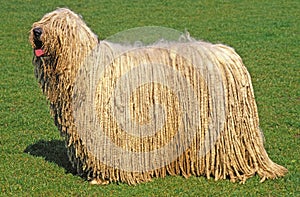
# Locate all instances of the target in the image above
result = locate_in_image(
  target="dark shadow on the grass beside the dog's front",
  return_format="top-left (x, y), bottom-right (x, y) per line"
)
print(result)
top-left (24, 140), bottom-right (77, 175)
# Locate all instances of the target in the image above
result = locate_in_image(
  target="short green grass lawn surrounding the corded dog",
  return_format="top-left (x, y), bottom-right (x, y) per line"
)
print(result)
top-left (0, 0), bottom-right (300, 196)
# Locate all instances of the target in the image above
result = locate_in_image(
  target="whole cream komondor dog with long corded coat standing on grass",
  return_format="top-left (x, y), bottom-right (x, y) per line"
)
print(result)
top-left (29, 8), bottom-right (287, 184)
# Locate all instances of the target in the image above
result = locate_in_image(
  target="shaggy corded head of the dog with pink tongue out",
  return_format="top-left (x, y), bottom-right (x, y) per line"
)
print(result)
top-left (29, 8), bottom-right (98, 85)
